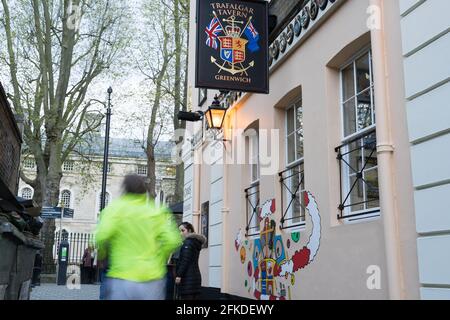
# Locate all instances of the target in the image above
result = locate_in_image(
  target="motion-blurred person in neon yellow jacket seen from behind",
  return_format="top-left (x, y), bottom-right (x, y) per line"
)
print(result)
top-left (95, 175), bottom-right (182, 300)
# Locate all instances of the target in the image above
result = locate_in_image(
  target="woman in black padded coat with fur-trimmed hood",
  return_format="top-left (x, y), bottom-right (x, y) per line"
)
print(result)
top-left (175, 222), bottom-right (206, 300)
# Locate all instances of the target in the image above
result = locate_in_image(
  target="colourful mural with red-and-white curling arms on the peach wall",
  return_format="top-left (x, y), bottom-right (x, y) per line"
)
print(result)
top-left (235, 192), bottom-right (321, 300)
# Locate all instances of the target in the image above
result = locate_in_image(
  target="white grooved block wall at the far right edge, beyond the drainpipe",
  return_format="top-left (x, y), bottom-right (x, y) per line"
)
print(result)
top-left (400, 0), bottom-right (450, 300)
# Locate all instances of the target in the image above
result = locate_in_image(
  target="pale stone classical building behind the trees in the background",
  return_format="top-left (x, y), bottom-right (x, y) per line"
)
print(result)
top-left (18, 137), bottom-right (176, 233)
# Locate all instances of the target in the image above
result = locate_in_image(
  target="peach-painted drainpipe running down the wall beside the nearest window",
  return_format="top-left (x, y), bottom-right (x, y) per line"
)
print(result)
top-left (370, 0), bottom-right (405, 300)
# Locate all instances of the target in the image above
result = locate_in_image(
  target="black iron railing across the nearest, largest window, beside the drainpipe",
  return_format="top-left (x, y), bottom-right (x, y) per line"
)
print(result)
top-left (335, 128), bottom-right (380, 220)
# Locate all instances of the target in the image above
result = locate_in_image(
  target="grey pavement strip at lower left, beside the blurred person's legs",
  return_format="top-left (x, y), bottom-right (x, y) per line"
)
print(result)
top-left (30, 283), bottom-right (100, 300)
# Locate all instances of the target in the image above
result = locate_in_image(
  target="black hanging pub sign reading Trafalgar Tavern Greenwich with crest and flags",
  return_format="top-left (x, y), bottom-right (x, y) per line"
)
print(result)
top-left (195, 0), bottom-right (269, 93)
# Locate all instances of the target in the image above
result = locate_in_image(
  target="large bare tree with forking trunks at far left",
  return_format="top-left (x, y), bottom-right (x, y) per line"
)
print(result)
top-left (0, 0), bottom-right (131, 270)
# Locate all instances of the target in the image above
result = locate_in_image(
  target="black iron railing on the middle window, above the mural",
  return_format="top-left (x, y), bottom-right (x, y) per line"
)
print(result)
top-left (278, 162), bottom-right (305, 229)
